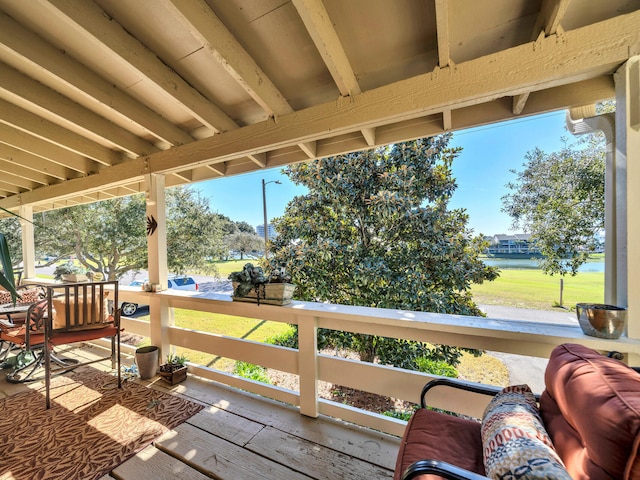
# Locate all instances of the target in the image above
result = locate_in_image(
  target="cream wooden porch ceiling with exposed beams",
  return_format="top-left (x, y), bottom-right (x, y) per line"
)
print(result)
top-left (0, 0), bottom-right (640, 211)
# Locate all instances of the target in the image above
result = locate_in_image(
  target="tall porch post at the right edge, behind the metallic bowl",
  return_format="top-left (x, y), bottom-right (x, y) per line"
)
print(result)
top-left (614, 55), bottom-right (640, 365)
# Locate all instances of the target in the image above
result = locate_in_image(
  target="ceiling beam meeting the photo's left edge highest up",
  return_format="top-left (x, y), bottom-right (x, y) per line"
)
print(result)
top-left (0, 12), bottom-right (193, 145)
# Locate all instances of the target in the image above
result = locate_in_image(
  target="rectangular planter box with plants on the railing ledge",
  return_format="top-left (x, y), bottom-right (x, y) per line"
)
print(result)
top-left (229, 263), bottom-right (296, 305)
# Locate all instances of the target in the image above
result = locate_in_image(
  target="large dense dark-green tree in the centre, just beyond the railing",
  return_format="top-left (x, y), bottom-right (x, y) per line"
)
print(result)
top-left (270, 135), bottom-right (497, 368)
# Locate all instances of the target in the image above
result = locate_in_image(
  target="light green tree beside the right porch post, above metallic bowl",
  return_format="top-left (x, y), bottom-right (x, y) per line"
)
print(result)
top-left (502, 136), bottom-right (605, 275)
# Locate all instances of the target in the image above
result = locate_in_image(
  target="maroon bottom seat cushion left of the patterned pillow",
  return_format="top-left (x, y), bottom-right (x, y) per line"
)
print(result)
top-left (393, 408), bottom-right (484, 480)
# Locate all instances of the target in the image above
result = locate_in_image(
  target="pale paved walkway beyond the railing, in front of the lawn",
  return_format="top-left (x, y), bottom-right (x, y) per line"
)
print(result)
top-left (479, 305), bottom-right (578, 393)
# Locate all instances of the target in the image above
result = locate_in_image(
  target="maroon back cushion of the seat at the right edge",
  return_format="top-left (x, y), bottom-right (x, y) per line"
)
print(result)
top-left (540, 344), bottom-right (640, 480)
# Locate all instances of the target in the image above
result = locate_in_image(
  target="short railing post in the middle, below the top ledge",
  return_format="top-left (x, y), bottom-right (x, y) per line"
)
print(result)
top-left (298, 317), bottom-right (319, 418)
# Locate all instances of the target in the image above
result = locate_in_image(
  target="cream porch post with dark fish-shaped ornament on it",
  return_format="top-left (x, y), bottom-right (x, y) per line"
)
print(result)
top-left (145, 174), bottom-right (173, 359)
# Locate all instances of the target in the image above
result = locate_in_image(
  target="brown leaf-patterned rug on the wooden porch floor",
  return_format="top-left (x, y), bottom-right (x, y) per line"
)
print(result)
top-left (0, 367), bottom-right (203, 480)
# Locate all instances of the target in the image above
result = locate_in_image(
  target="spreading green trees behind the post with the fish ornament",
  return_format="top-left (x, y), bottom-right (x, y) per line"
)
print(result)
top-left (35, 188), bottom-right (222, 280)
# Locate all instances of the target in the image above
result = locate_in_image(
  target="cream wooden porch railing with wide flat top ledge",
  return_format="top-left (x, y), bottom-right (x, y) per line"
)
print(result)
top-left (120, 287), bottom-right (640, 435)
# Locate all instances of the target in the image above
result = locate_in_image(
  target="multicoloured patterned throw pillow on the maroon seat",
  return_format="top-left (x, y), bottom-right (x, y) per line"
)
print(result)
top-left (481, 385), bottom-right (571, 480)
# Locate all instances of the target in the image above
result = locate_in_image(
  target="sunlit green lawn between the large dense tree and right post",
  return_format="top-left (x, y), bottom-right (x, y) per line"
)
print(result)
top-left (471, 269), bottom-right (604, 310)
